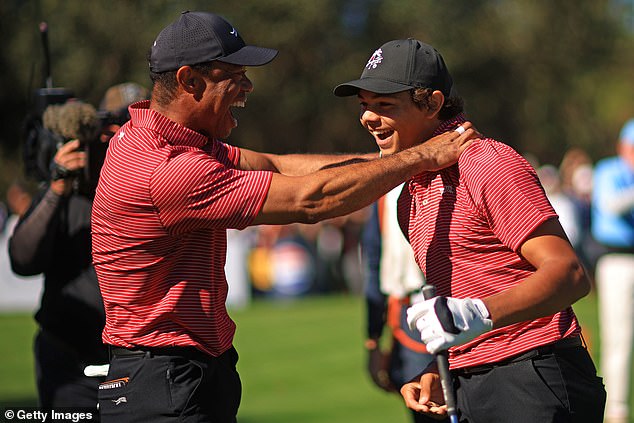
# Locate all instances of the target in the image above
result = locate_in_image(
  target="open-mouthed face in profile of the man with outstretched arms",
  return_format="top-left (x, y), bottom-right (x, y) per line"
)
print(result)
top-left (190, 61), bottom-right (253, 139)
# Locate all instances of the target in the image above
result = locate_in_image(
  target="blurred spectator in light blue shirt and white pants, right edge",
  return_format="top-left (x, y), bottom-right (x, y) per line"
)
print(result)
top-left (592, 119), bottom-right (634, 423)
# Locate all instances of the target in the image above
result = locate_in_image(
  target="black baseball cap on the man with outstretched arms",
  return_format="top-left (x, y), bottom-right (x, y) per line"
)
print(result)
top-left (150, 11), bottom-right (277, 73)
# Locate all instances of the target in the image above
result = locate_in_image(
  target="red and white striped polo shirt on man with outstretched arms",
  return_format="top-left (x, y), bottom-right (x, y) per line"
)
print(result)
top-left (92, 101), bottom-right (272, 356)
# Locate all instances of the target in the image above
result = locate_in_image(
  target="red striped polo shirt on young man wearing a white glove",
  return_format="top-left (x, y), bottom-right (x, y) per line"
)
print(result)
top-left (398, 119), bottom-right (580, 369)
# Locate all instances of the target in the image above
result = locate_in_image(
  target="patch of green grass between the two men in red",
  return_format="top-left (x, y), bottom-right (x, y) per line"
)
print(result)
top-left (232, 296), bottom-right (409, 423)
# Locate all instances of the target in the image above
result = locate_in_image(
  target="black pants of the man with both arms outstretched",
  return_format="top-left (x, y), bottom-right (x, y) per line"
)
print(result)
top-left (98, 348), bottom-right (242, 423)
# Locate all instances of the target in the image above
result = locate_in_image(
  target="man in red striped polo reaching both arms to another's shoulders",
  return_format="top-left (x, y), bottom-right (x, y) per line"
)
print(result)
top-left (92, 12), bottom-right (475, 422)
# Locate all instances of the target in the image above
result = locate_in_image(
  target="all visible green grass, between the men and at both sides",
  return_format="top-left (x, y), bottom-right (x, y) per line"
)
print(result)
top-left (0, 294), bottom-right (634, 423)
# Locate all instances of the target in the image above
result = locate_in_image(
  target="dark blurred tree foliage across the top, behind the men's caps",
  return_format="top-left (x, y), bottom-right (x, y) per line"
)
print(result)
top-left (0, 0), bottom-right (634, 191)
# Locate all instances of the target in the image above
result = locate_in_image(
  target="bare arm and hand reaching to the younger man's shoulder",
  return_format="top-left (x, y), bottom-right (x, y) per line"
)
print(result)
top-left (249, 123), bottom-right (476, 225)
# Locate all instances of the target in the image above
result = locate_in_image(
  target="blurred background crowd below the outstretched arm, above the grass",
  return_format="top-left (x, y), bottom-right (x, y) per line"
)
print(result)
top-left (226, 209), bottom-right (369, 307)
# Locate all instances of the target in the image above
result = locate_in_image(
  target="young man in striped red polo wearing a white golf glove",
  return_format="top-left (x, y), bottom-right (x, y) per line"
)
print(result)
top-left (334, 39), bottom-right (605, 423)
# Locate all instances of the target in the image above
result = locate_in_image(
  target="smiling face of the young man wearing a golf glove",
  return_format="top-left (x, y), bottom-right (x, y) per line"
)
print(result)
top-left (358, 90), bottom-right (439, 156)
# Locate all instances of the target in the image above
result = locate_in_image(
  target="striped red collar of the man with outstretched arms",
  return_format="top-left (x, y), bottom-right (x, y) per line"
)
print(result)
top-left (129, 100), bottom-right (209, 147)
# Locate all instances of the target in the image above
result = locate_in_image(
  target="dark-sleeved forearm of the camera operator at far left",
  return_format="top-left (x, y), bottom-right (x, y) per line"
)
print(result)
top-left (9, 189), bottom-right (61, 275)
